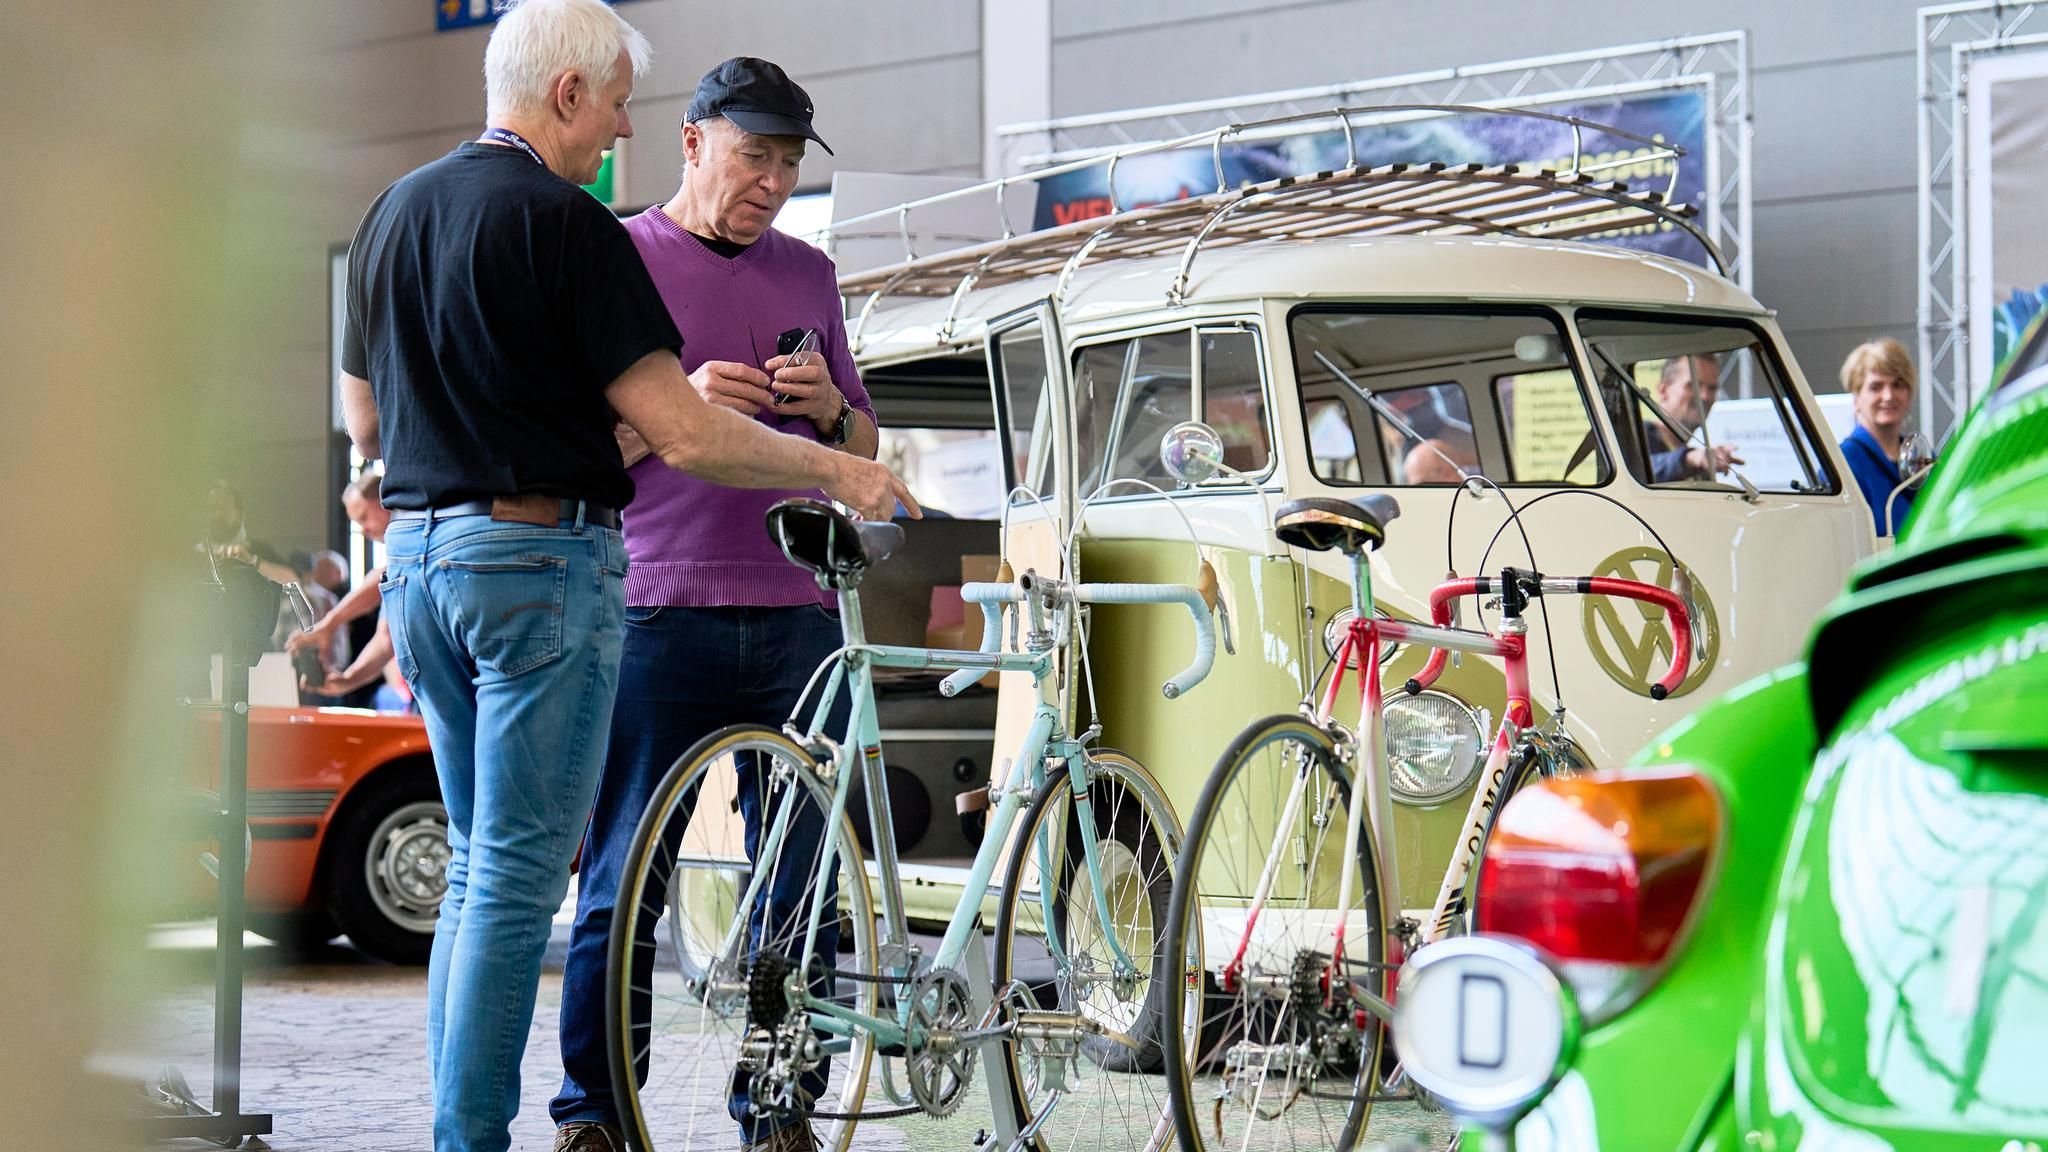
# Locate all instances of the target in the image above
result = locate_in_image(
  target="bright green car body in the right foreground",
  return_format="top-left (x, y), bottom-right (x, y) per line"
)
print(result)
top-left (1520, 309), bottom-right (2048, 1152)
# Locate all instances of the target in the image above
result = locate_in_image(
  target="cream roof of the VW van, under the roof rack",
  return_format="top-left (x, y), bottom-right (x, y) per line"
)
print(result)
top-left (848, 236), bottom-right (1763, 363)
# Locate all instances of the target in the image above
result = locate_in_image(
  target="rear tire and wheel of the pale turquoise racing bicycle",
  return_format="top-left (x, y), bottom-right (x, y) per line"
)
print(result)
top-left (606, 724), bottom-right (881, 1152)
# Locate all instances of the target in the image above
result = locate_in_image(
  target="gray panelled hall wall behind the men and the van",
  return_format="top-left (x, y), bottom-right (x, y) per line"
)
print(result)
top-left (256, 0), bottom-right (1917, 545)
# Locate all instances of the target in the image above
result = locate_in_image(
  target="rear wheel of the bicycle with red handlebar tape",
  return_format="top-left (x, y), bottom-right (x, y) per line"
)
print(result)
top-left (1163, 715), bottom-right (1386, 1152)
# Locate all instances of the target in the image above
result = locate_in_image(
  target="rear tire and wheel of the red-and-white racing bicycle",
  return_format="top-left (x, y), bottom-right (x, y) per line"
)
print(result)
top-left (1161, 715), bottom-right (1389, 1152)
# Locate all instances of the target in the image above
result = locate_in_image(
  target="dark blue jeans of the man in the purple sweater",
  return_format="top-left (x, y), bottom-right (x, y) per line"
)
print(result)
top-left (549, 605), bottom-right (846, 1142)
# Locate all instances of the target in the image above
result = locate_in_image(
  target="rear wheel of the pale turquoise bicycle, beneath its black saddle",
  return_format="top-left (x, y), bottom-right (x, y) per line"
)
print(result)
top-left (606, 726), bottom-right (879, 1152)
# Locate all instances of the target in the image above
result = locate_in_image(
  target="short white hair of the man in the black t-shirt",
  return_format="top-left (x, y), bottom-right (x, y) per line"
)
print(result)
top-left (483, 0), bottom-right (651, 117)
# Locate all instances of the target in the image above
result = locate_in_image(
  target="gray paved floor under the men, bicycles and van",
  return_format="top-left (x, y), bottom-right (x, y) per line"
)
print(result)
top-left (100, 924), bottom-right (1452, 1152)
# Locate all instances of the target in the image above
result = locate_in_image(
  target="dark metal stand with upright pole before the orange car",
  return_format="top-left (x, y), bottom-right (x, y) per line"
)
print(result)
top-left (139, 562), bottom-right (285, 1148)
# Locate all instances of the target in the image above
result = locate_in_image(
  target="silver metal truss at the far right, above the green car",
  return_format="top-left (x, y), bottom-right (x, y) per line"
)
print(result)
top-left (1919, 0), bottom-right (2048, 441)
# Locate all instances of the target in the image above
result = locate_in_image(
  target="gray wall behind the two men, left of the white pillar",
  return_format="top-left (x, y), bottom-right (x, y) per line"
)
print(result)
top-left (237, 0), bottom-right (981, 549)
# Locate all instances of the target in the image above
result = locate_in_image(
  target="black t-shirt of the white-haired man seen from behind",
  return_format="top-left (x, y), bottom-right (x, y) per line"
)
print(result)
top-left (342, 141), bottom-right (682, 508)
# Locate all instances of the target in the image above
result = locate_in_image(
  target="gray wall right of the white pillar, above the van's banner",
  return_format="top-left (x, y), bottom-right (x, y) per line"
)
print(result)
top-left (1053, 0), bottom-right (1921, 392)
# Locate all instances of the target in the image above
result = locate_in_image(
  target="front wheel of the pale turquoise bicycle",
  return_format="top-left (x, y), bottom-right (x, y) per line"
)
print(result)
top-left (995, 750), bottom-right (1184, 1152)
